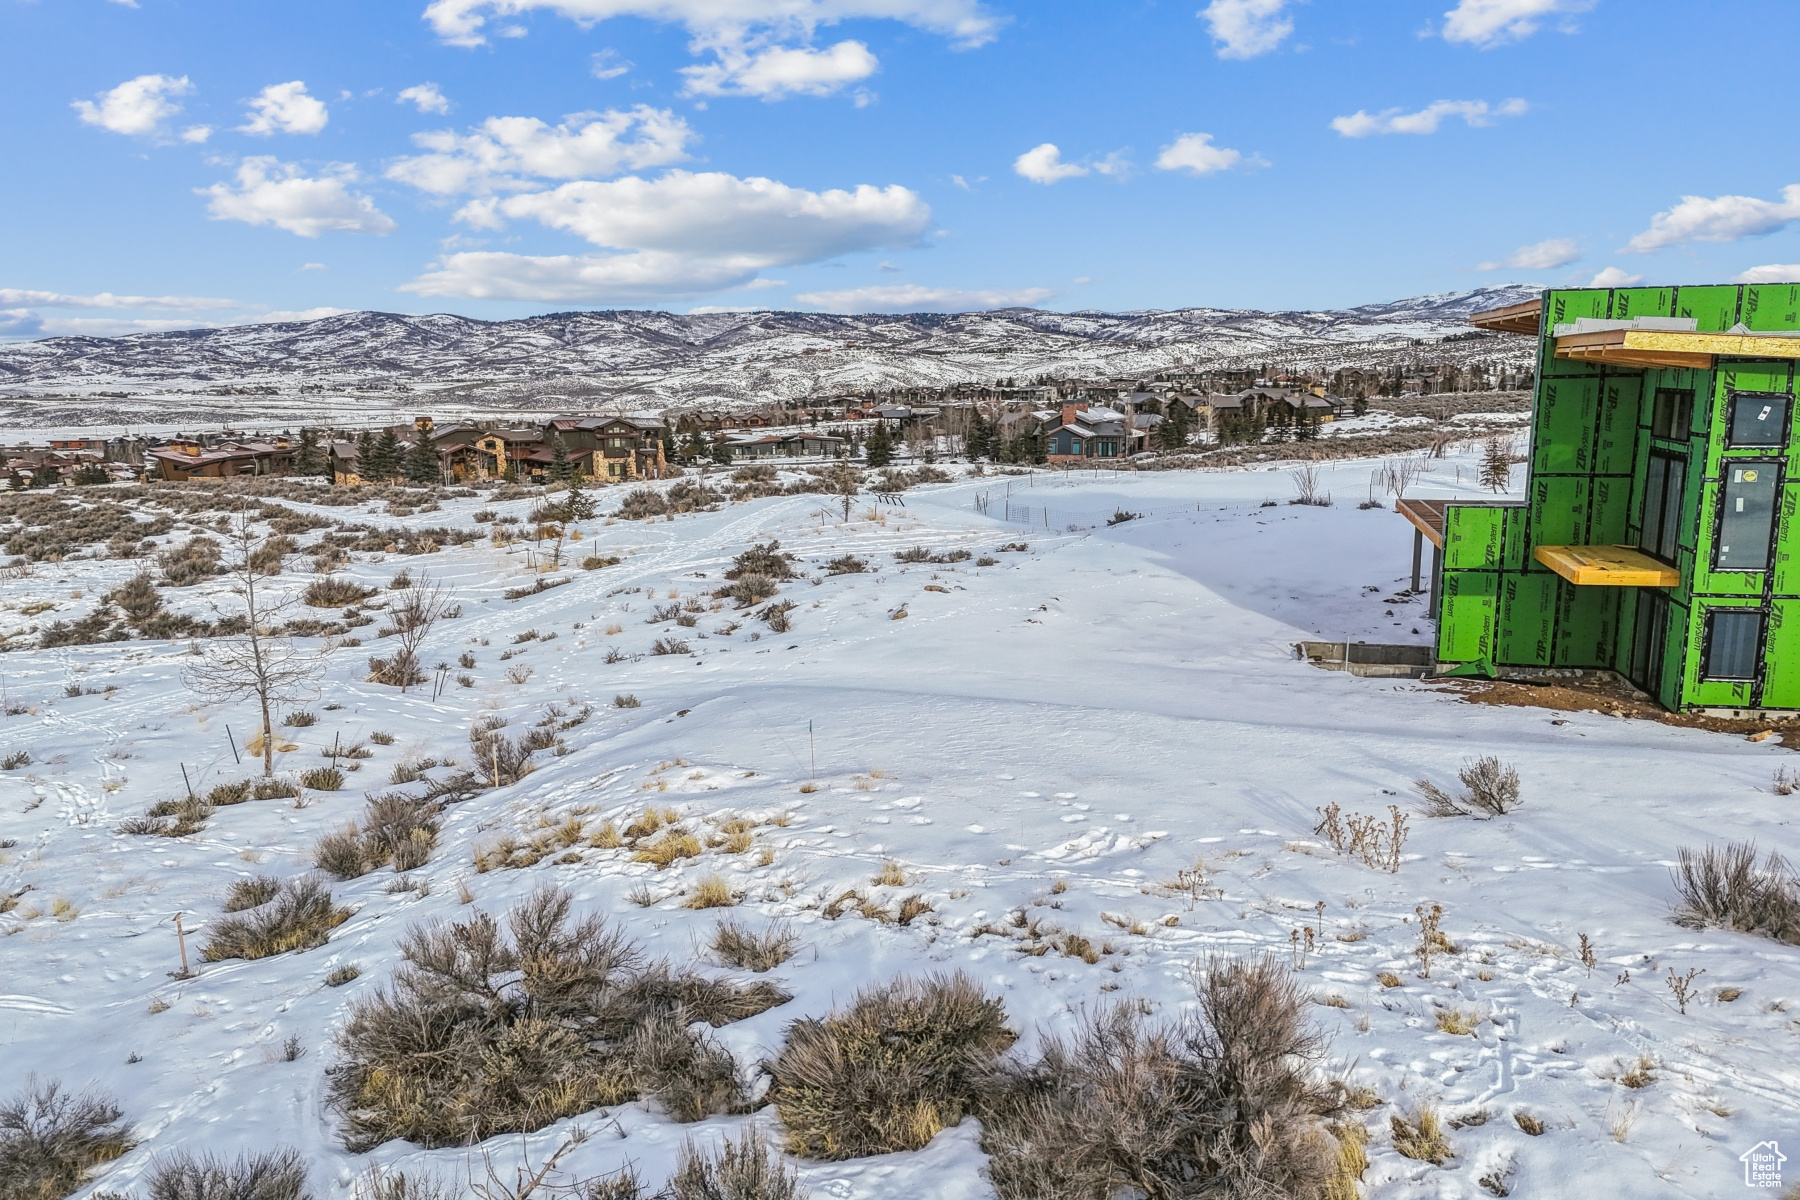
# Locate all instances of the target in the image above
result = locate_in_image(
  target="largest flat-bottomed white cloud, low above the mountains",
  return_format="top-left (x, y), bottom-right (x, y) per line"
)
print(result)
top-left (403, 171), bottom-right (931, 300)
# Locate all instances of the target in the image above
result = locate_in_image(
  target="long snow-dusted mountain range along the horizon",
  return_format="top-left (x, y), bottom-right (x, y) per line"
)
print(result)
top-left (0, 288), bottom-right (1532, 423)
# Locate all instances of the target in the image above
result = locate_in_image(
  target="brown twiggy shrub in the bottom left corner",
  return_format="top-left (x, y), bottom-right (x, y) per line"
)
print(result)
top-left (0, 1076), bottom-right (131, 1200)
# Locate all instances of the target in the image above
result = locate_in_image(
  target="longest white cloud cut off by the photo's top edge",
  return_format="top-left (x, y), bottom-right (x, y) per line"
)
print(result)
top-left (425, 0), bottom-right (1001, 45)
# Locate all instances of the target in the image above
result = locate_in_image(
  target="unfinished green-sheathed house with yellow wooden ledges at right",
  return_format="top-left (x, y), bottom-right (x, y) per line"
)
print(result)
top-left (1399, 284), bottom-right (1800, 711)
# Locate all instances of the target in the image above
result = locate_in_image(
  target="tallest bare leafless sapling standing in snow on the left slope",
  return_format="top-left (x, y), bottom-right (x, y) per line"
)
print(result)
top-left (182, 513), bottom-right (322, 775)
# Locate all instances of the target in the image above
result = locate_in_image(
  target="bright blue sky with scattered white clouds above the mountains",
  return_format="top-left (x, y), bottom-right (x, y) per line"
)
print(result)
top-left (0, 0), bottom-right (1800, 338)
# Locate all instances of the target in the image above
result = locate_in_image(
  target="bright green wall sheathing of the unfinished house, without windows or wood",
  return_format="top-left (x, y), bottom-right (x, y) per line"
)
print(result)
top-left (1436, 284), bottom-right (1800, 709)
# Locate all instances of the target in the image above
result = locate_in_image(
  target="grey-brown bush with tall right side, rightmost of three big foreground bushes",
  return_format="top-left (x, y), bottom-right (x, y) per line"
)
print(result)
top-left (981, 959), bottom-right (1361, 1200)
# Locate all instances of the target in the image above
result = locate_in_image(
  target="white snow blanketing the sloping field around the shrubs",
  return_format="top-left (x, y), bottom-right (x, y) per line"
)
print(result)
top-left (0, 459), bottom-right (1800, 1200)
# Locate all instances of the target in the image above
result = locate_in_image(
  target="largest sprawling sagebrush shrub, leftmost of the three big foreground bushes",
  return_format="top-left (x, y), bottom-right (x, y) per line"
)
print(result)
top-left (329, 887), bottom-right (788, 1153)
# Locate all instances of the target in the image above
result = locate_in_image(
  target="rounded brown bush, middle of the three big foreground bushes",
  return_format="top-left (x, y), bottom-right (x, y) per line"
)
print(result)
top-left (769, 975), bottom-right (1015, 1160)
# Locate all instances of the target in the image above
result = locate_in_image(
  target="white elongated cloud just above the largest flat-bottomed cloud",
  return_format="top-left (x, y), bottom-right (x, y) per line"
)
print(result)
top-left (387, 104), bottom-right (693, 196)
